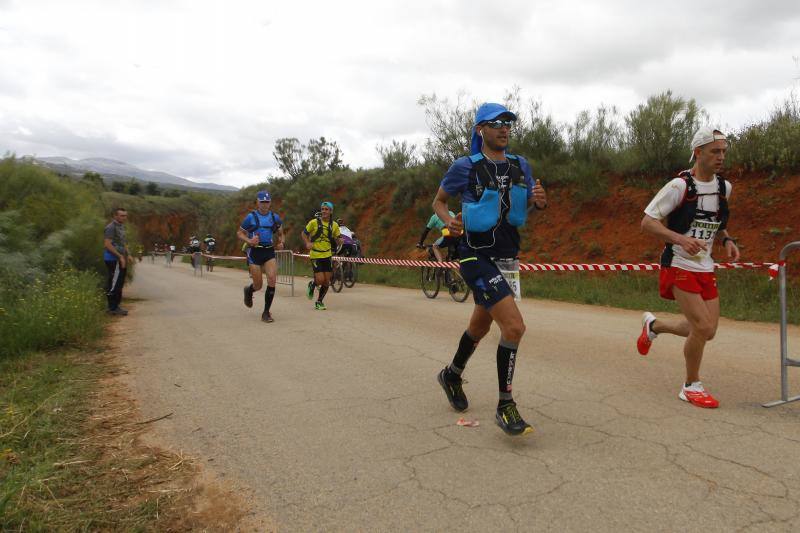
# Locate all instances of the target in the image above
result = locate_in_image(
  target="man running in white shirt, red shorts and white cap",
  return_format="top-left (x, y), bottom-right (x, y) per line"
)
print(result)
top-left (636, 127), bottom-right (739, 408)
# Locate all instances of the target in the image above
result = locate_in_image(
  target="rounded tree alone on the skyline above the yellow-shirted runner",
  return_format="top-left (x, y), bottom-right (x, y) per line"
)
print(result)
top-left (272, 137), bottom-right (347, 181)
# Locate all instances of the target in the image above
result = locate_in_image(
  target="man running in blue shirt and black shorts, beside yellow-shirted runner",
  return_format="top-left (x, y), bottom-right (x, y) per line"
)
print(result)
top-left (236, 191), bottom-right (283, 323)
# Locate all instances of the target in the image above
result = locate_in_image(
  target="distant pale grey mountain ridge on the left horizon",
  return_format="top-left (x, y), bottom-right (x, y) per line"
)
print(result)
top-left (31, 157), bottom-right (238, 192)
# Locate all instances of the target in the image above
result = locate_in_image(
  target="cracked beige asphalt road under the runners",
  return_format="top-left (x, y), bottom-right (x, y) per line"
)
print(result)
top-left (119, 262), bottom-right (800, 532)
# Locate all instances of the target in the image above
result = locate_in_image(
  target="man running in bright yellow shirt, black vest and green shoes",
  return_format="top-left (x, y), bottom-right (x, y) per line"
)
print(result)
top-left (301, 202), bottom-right (342, 310)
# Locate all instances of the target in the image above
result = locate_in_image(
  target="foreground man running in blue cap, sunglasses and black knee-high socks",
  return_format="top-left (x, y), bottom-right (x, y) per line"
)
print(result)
top-left (433, 103), bottom-right (547, 435)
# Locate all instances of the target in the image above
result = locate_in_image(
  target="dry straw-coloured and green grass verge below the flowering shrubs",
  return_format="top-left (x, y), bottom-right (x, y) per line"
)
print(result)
top-left (0, 342), bottom-right (260, 531)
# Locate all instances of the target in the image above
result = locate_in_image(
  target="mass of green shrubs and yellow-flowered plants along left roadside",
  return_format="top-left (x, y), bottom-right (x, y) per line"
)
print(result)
top-left (0, 158), bottom-right (111, 358)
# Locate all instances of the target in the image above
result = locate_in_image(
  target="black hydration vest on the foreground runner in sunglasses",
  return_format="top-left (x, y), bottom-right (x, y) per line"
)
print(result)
top-left (464, 154), bottom-right (525, 251)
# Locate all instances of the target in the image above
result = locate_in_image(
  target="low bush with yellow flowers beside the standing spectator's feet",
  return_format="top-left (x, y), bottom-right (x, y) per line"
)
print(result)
top-left (0, 270), bottom-right (105, 356)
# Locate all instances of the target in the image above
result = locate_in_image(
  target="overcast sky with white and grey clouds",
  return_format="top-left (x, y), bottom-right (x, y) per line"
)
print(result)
top-left (0, 0), bottom-right (800, 186)
